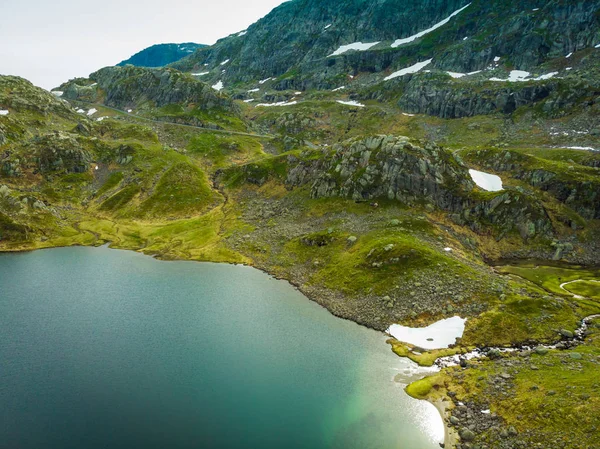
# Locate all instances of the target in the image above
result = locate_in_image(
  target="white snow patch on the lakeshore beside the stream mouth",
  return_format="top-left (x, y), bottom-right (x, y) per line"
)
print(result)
top-left (386, 316), bottom-right (467, 349)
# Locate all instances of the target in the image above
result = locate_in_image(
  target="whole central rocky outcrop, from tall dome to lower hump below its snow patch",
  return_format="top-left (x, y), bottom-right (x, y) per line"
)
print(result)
top-left (270, 136), bottom-right (553, 240)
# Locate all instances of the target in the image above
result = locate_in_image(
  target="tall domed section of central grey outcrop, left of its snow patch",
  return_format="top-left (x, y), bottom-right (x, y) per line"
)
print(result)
top-left (287, 136), bottom-right (474, 210)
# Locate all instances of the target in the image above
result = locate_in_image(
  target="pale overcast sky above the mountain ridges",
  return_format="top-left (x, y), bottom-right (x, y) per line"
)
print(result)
top-left (0, 0), bottom-right (283, 89)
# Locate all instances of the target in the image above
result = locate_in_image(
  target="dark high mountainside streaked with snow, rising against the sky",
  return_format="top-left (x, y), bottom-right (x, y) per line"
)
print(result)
top-left (173, 0), bottom-right (600, 118)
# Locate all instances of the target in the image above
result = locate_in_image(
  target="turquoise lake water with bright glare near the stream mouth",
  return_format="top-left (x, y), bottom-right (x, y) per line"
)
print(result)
top-left (0, 248), bottom-right (443, 449)
